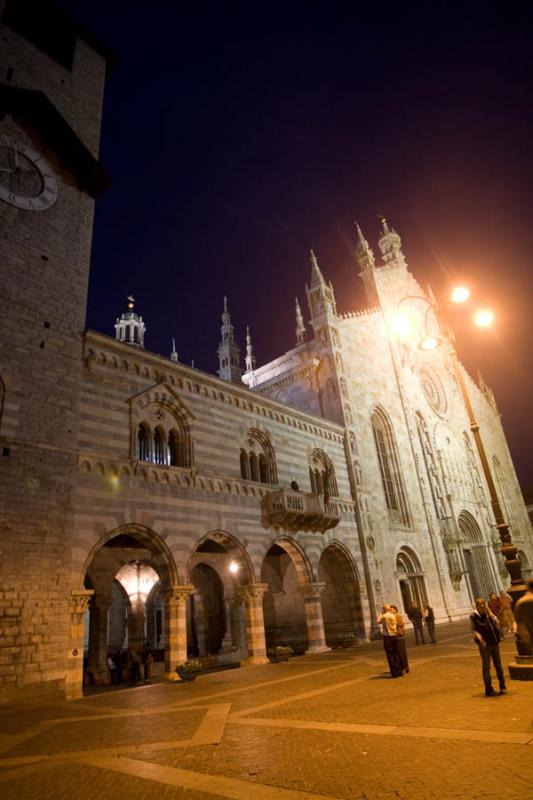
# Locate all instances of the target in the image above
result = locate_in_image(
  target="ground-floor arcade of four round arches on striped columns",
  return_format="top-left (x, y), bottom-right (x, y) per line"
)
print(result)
top-left (67, 525), bottom-right (365, 697)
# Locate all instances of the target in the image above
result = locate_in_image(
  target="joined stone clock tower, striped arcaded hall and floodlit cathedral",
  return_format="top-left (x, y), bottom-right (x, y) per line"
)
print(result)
top-left (0, 0), bottom-right (533, 700)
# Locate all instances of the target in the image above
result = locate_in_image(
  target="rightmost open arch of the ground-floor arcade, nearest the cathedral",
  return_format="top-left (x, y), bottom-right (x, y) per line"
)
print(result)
top-left (318, 541), bottom-right (365, 647)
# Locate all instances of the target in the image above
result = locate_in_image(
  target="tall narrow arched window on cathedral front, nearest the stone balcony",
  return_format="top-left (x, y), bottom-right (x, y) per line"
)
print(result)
top-left (371, 408), bottom-right (411, 527)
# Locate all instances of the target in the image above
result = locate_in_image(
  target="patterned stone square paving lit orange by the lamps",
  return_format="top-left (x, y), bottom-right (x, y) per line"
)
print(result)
top-left (0, 623), bottom-right (533, 800)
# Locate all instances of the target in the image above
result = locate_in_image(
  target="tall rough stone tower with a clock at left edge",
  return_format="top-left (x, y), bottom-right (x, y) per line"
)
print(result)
top-left (0, 0), bottom-right (109, 700)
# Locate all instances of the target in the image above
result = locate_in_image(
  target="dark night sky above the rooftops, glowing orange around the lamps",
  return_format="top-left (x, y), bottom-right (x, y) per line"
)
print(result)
top-left (62, 0), bottom-right (533, 485)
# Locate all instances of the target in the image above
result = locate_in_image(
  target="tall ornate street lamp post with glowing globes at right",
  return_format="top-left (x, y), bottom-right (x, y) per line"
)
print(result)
top-left (386, 287), bottom-right (533, 680)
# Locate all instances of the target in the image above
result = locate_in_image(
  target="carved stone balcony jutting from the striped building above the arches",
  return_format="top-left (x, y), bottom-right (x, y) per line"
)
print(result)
top-left (263, 489), bottom-right (340, 533)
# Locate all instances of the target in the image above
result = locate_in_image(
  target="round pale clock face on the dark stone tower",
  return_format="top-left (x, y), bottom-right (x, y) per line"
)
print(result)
top-left (0, 136), bottom-right (57, 211)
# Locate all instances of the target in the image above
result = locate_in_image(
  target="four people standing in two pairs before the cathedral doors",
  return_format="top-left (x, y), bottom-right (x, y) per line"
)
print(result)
top-left (378, 603), bottom-right (437, 678)
